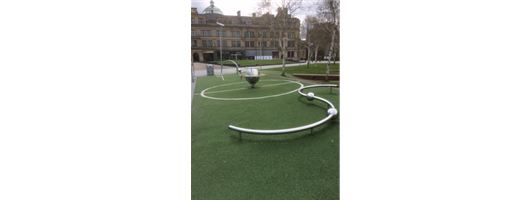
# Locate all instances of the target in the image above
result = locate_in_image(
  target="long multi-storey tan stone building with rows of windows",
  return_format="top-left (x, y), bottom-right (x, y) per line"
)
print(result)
top-left (191, 0), bottom-right (303, 62)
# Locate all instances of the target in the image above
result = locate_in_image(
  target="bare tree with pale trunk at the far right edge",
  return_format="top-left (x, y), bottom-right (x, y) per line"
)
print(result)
top-left (317, 0), bottom-right (340, 81)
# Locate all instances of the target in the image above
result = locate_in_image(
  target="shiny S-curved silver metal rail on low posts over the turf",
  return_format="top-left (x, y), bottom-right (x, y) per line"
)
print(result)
top-left (228, 84), bottom-right (338, 140)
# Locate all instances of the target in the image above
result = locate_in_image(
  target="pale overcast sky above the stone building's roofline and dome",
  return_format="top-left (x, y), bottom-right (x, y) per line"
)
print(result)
top-left (191, 0), bottom-right (316, 21)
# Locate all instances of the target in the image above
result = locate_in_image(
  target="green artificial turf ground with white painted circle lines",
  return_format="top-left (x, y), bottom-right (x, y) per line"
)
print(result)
top-left (191, 70), bottom-right (341, 200)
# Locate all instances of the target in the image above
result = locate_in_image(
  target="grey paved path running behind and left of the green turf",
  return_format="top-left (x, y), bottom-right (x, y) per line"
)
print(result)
top-left (191, 61), bottom-right (339, 102)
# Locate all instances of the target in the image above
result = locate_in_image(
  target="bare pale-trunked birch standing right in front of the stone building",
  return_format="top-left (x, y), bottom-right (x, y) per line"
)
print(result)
top-left (257, 0), bottom-right (304, 76)
